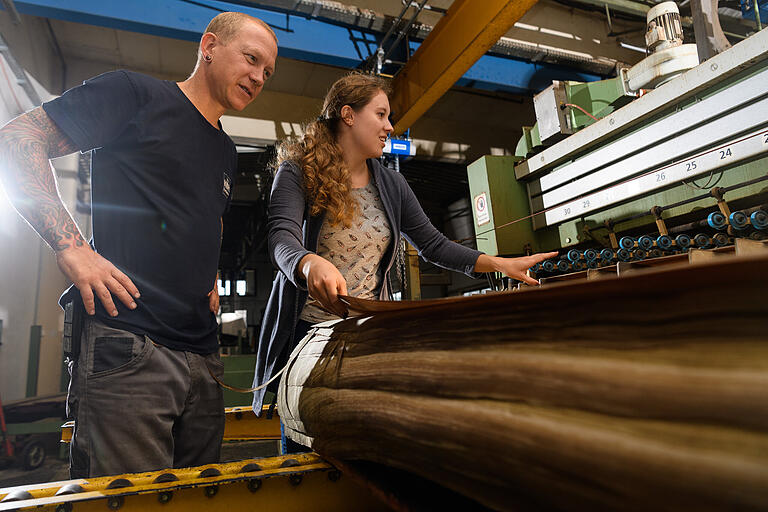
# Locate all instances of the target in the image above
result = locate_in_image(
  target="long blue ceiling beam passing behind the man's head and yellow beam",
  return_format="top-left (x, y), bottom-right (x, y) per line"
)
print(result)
top-left (7, 0), bottom-right (603, 94)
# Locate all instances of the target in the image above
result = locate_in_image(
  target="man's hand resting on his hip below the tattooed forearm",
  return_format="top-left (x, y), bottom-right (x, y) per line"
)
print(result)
top-left (56, 245), bottom-right (139, 316)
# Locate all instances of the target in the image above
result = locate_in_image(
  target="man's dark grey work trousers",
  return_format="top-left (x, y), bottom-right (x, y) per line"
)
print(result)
top-left (67, 318), bottom-right (224, 478)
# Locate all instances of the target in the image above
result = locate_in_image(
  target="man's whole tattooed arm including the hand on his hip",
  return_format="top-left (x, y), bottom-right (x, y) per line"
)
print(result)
top-left (0, 107), bottom-right (139, 316)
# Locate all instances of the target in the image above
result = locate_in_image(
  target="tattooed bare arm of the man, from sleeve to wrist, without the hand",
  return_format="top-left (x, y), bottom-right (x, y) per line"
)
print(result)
top-left (0, 107), bottom-right (85, 251)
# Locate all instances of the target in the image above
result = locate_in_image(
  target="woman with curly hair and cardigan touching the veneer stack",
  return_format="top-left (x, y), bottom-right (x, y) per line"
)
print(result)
top-left (253, 74), bottom-right (557, 414)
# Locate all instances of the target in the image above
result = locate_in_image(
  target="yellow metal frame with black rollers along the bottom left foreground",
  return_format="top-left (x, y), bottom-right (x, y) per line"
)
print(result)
top-left (0, 453), bottom-right (389, 512)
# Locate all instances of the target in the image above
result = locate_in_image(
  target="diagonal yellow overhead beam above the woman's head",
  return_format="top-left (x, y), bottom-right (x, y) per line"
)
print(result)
top-left (392, 0), bottom-right (536, 134)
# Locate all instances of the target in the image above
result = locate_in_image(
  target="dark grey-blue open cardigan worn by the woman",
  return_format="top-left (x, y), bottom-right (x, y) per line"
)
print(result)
top-left (253, 159), bottom-right (482, 414)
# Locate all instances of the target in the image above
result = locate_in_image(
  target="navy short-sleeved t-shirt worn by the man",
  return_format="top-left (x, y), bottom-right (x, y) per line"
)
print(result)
top-left (43, 71), bottom-right (237, 354)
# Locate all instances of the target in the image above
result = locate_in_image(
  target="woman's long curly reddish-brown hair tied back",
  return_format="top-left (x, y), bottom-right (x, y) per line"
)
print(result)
top-left (276, 73), bottom-right (390, 227)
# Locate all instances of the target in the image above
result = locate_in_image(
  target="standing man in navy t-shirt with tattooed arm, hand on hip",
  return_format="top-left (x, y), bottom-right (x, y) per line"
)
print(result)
top-left (0, 12), bottom-right (277, 478)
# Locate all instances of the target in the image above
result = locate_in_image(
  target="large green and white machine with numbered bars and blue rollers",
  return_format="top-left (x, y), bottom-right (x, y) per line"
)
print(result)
top-left (467, 7), bottom-right (768, 264)
